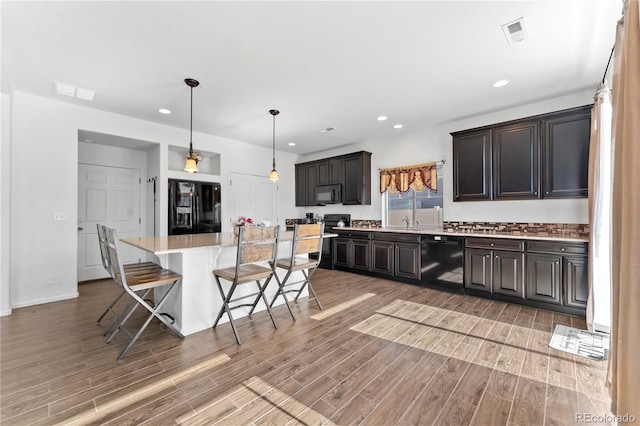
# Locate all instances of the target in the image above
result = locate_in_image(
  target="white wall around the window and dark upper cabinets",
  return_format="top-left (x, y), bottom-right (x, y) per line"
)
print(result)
top-left (296, 89), bottom-right (595, 223)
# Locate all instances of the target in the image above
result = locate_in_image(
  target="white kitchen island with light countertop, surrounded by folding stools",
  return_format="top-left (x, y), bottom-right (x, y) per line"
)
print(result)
top-left (121, 231), bottom-right (324, 336)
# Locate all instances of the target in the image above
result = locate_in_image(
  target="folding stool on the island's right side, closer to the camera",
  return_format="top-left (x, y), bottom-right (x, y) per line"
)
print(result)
top-left (213, 226), bottom-right (280, 344)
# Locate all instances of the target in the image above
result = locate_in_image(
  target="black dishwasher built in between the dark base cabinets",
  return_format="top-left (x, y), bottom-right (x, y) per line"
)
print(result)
top-left (420, 235), bottom-right (464, 293)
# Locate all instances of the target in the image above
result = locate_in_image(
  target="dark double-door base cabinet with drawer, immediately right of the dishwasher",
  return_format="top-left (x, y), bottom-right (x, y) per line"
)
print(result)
top-left (464, 238), bottom-right (524, 298)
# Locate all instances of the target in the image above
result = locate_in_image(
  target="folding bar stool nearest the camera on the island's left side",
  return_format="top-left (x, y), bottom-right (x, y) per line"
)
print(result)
top-left (104, 227), bottom-right (184, 361)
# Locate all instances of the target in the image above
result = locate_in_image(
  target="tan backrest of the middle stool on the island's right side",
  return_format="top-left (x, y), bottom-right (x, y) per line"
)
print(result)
top-left (237, 226), bottom-right (280, 265)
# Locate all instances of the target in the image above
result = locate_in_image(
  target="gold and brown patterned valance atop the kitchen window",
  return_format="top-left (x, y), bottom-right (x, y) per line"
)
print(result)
top-left (380, 162), bottom-right (438, 194)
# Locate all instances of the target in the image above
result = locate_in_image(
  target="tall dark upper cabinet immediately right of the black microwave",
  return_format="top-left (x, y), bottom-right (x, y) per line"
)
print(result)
top-left (342, 151), bottom-right (371, 205)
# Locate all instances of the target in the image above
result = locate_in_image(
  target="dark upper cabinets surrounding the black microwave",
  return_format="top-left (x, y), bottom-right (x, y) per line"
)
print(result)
top-left (295, 151), bottom-right (371, 206)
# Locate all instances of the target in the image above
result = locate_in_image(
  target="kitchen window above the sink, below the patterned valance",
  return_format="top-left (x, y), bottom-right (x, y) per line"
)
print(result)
top-left (383, 164), bottom-right (443, 227)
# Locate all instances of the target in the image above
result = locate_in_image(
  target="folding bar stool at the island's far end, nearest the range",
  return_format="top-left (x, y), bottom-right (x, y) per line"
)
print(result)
top-left (270, 223), bottom-right (324, 321)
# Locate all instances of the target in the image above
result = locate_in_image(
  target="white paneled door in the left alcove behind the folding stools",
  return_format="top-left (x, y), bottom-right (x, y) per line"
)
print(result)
top-left (78, 164), bottom-right (142, 281)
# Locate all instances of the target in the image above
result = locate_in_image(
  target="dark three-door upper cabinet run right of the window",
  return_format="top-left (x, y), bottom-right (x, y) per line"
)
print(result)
top-left (451, 105), bottom-right (591, 201)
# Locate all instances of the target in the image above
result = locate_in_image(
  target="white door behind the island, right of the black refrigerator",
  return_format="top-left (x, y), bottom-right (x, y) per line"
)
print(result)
top-left (229, 172), bottom-right (278, 226)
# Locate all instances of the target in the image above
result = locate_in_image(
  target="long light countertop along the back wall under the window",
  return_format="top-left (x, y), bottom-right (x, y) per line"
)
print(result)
top-left (339, 227), bottom-right (589, 243)
